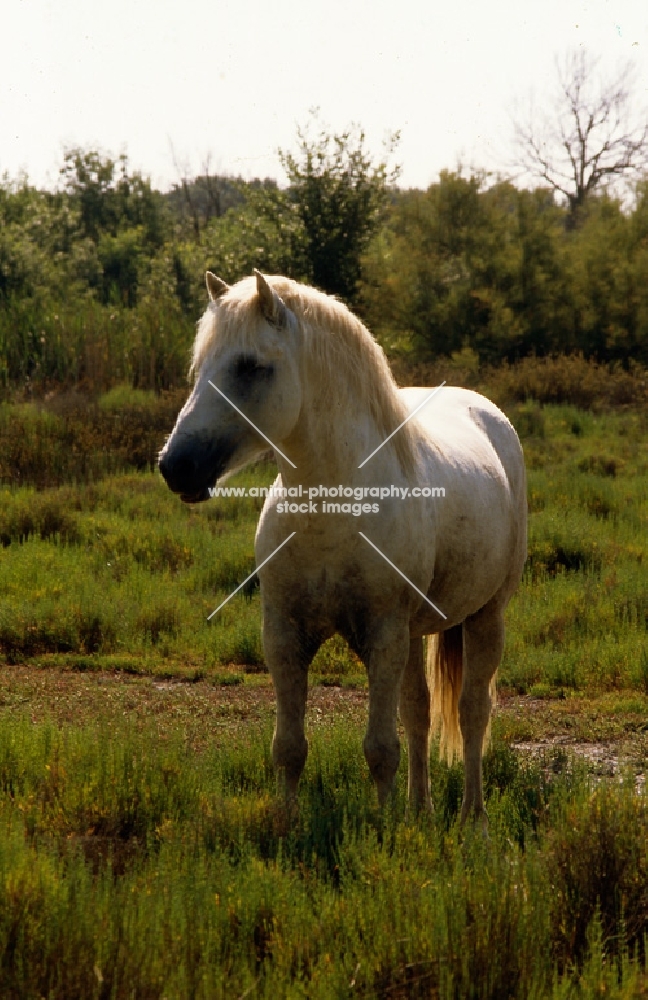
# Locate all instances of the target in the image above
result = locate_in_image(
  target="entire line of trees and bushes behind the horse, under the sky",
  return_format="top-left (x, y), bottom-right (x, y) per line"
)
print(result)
top-left (0, 52), bottom-right (648, 390)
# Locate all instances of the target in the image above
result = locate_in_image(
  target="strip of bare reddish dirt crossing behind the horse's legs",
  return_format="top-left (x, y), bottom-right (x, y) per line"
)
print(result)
top-left (0, 665), bottom-right (648, 786)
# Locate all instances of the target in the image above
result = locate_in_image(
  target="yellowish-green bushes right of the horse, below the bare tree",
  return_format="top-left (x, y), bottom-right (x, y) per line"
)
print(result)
top-left (359, 172), bottom-right (648, 365)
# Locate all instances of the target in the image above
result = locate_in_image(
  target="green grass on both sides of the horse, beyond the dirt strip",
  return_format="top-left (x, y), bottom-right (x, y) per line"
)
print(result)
top-left (0, 390), bottom-right (648, 693)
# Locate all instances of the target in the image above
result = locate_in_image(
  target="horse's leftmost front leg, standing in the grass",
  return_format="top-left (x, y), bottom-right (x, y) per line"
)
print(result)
top-left (263, 609), bottom-right (313, 799)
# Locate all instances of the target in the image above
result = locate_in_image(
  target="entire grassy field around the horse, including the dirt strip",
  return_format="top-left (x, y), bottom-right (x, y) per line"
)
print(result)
top-left (0, 388), bottom-right (648, 1000)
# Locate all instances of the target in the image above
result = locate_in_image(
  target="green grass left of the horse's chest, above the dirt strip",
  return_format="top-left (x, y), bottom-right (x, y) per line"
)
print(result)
top-left (0, 467), bottom-right (275, 672)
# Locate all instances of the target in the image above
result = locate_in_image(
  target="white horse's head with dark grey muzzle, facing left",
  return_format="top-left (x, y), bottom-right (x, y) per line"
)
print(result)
top-left (159, 271), bottom-right (302, 503)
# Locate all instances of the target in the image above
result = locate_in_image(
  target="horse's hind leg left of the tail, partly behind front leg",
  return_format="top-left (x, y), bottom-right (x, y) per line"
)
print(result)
top-left (400, 637), bottom-right (432, 810)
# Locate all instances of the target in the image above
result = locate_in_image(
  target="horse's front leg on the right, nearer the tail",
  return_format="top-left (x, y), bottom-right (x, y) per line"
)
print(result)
top-left (364, 618), bottom-right (409, 805)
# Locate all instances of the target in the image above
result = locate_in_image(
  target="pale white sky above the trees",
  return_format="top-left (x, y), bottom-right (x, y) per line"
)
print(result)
top-left (0, 0), bottom-right (648, 187)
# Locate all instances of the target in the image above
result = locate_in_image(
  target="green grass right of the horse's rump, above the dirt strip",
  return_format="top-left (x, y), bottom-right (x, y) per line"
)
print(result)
top-left (500, 405), bottom-right (648, 692)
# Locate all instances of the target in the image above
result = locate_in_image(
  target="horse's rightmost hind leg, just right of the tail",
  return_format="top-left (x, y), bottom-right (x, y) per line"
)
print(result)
top-left (459, 599), bottom-right (504, 822)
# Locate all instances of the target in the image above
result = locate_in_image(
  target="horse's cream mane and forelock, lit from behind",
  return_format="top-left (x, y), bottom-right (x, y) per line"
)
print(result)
top-left (190, 276), bottom-right (415, 472)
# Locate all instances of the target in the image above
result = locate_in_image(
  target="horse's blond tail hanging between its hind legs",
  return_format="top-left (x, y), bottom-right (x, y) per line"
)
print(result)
top-left (426, 624), bottom-right (463, 764)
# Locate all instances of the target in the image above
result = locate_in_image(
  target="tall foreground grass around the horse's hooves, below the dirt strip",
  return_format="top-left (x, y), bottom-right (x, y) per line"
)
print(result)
top-left (0, 714), bottom-right (648, 1000)
